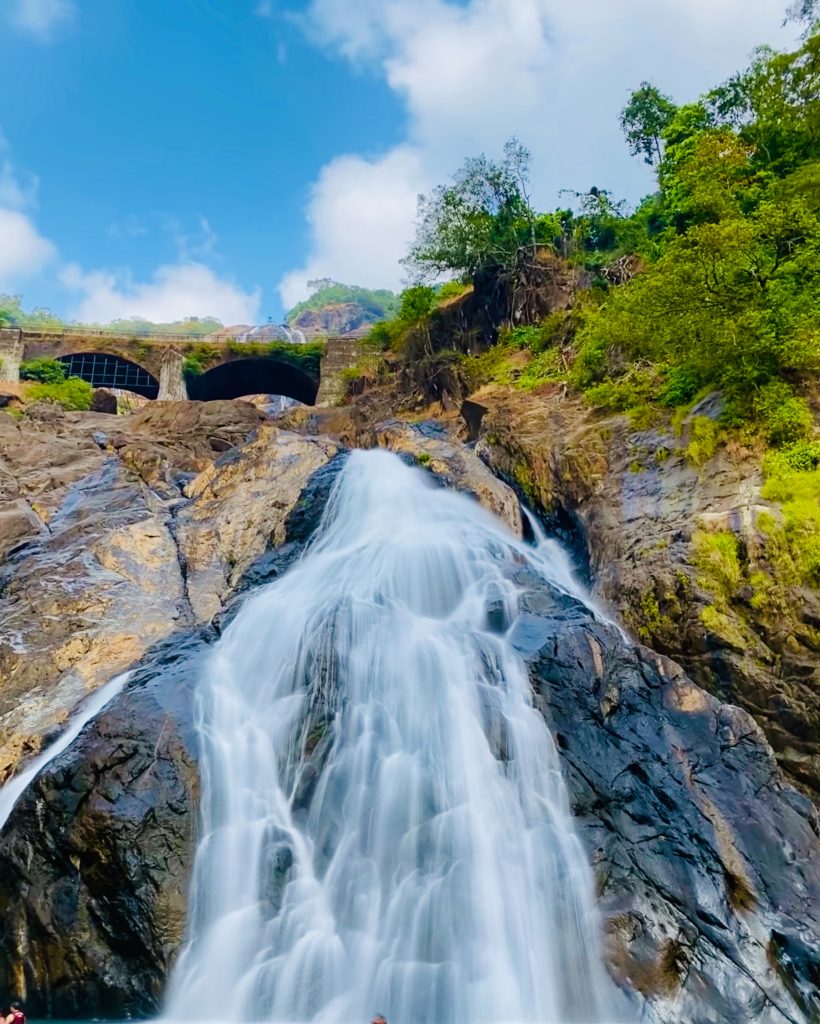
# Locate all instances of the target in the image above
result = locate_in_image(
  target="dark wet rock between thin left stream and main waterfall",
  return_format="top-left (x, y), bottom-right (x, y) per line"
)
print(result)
top-left (0, 636), bottom-right (205, 1019)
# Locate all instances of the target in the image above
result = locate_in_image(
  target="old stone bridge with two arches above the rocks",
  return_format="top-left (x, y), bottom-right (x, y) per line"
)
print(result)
top-left (0, 328), bottom-right (360, 406)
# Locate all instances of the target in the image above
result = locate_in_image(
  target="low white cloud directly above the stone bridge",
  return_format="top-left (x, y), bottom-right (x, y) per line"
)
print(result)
top-left (60, 261), bottom-right (261, 324)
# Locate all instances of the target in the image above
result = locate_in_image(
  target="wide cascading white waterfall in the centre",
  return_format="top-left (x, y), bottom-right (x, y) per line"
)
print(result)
top-left (167, 452), bottom-right (615, 1024)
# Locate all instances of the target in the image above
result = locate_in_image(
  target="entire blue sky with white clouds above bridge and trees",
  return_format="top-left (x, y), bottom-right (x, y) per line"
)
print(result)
top-left (0, 0), bottom-right (790, 323)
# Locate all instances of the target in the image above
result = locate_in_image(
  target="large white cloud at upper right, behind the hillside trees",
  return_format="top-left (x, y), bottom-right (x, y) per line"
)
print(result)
top-left (279, 0), bottom-right (787, 304)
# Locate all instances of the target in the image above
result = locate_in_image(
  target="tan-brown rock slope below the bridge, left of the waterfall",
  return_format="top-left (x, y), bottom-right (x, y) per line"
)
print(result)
top-left (0, 401), bottom-right (338, 783)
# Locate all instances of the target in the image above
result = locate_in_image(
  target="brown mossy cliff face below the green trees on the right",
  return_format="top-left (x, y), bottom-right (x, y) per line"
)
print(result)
top-left (476, 386), bottom-right (820, 800)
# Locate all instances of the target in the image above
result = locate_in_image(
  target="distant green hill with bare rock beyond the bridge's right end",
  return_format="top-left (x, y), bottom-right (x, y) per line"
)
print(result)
top-left (285, 278), bottom-right (399, 337)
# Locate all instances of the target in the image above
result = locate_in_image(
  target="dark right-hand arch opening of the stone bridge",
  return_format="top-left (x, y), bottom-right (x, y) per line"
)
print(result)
top-left (186, 356), bottom-right (318, 406)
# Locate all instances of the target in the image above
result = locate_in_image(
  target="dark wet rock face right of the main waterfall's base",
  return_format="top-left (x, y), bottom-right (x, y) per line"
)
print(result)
top-left (517, 574), bottom-right (820, 1024)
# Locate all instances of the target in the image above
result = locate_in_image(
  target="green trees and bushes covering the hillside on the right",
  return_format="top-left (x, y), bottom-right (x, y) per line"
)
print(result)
top-left (374, 24), bottom-right (820, 446)
